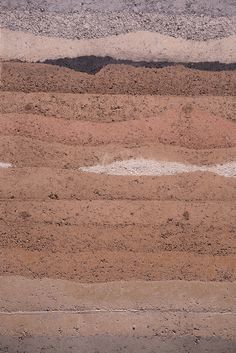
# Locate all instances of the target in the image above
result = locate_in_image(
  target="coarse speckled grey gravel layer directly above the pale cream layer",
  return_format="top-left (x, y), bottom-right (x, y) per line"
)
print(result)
top-left (0, 9), bottom-right (236, 41)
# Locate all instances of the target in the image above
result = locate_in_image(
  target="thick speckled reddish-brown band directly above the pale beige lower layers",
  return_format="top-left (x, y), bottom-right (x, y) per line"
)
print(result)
top-left (0, 200), bottom-right (236, 282)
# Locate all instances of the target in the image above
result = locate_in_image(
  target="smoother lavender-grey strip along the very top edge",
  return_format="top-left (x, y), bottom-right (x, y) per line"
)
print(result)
top-left (0, 0), bottom-right (236, 17)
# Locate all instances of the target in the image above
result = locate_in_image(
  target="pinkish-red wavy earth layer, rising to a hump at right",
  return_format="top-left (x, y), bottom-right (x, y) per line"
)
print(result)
top-left (0, 106), bottom-right (236, 149)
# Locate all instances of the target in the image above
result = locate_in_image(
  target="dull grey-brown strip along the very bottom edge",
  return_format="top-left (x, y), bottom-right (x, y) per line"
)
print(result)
top-left (0, 329), bottom-right (236, 353)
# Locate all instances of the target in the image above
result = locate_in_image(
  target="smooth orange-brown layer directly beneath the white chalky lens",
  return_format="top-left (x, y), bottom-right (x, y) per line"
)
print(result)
top-left (0, 168), bottom-right (236, 201)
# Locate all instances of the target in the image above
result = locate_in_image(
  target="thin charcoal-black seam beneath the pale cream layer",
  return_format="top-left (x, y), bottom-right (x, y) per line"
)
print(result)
top-left (43, 55), bottom-right (236, 74)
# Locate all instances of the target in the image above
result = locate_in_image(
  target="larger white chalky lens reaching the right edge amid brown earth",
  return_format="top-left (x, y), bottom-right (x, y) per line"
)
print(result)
top-left (80, 159), bottom-right (236, 177)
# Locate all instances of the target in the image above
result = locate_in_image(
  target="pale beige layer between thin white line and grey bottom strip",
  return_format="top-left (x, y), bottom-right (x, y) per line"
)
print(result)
top-left (0, 312), bottom-right (236, 339)
